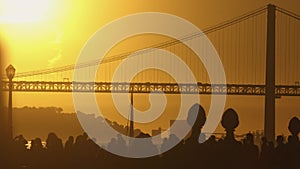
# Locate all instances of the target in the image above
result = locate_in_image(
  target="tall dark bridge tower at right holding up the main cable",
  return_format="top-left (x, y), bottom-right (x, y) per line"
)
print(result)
top-left (264, 5), bottom-right (276, 141)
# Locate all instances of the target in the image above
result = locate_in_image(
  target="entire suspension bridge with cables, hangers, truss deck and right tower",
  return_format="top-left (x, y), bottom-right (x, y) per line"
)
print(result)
top-left (2, 5), bottom-right (300, 140)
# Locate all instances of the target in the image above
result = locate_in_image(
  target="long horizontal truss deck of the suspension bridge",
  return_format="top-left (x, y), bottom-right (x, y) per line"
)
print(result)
top-left (1, 81), bottom-right (300, 97)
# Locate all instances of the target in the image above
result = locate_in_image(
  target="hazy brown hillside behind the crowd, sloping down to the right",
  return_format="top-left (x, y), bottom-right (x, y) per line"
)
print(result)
top-left (13, 106), bottom-right (141, 141)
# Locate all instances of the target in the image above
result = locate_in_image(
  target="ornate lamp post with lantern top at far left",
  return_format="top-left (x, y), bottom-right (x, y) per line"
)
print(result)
top-left (6, 65), bottom-right (16, 140)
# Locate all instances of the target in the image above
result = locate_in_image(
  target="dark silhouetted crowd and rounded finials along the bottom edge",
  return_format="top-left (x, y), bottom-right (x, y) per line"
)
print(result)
top-left (0, 104), bottom-right (300, 169)
